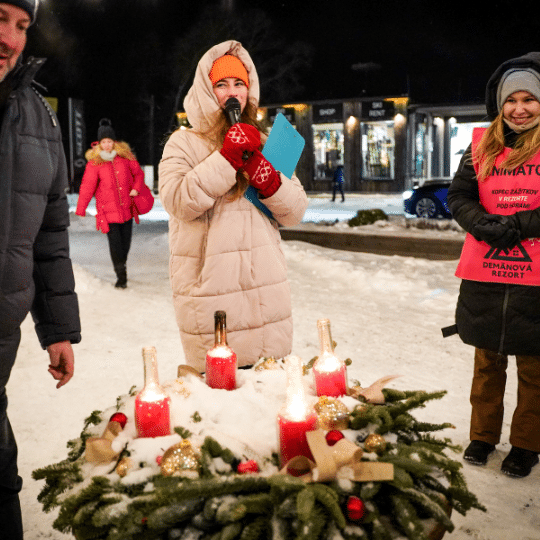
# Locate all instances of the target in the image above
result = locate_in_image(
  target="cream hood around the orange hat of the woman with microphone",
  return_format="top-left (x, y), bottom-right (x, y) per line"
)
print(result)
top-left (184, 40), bottom-right (260, 133)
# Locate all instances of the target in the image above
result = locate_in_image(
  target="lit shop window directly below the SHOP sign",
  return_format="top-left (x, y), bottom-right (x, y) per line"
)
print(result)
top-left (313, 123), bottom-right (343, 180)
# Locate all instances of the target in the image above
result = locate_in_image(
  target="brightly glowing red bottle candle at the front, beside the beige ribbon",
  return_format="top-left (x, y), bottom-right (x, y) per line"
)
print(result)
top-left (277, 356), bottom-right (317, 467)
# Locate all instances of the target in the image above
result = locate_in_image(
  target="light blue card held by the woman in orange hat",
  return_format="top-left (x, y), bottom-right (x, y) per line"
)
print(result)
top-left (262, 113), bottom-right (305, 178)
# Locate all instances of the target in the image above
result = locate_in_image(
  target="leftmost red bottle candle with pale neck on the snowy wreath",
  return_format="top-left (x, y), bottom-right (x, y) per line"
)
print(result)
top-left (135, 347), bottom-right (171, 437)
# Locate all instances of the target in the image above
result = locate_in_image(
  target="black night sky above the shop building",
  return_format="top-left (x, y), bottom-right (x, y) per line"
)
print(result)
top-left (22, 0), bottom-right (540, 165)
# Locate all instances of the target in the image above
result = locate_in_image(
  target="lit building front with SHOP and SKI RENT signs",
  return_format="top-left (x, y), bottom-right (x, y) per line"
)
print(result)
top-left (178, 96), bottom-right (489, 193)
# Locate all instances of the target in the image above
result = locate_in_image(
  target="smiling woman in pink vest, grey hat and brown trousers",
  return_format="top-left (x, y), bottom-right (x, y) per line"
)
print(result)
top-left (448, 52), bottom-right (540, 477)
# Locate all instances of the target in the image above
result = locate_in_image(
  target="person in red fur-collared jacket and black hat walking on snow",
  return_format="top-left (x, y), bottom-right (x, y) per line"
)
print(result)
top-left (75, 118), bottom-right (144, 289)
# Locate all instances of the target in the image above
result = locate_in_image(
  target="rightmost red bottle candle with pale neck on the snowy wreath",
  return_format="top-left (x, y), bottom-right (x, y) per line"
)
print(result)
top-left (313, 319), bottom-right (347, 397)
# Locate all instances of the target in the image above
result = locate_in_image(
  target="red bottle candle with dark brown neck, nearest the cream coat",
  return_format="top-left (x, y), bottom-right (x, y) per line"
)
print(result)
top-left (206, 311), bottom-right (238, 390)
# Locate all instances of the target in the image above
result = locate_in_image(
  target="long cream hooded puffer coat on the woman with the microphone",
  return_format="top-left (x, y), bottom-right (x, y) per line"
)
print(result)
top-left (159, 41), bottom-right (307, 371)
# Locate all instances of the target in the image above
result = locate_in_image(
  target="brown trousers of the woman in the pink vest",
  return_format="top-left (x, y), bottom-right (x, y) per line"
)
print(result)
top-left (470, 349), bottom-right (540, 452)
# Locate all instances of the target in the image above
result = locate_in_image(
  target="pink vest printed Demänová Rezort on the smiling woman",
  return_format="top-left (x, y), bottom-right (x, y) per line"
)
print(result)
top-left (456, 128), bottom-right (540, 285)
